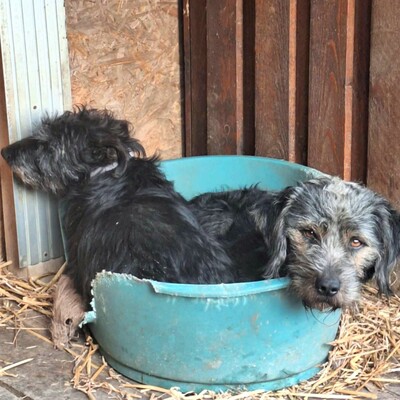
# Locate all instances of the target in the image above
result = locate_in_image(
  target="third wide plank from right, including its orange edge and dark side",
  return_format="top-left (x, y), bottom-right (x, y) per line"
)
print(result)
top-left (256, 0), bottom-right (310, 163)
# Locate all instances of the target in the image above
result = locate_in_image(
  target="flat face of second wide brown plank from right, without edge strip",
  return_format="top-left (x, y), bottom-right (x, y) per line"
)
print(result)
top-left (308, 0), bottom-right (347, 176)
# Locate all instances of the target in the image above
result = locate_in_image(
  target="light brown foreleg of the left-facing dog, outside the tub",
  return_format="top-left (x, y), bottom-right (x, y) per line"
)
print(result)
top-left (50, 275), bottom-right (85, 349)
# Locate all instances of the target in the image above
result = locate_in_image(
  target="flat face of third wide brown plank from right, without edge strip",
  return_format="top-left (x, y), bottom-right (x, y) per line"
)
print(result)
top-left (255, 0), bottom-right (290, 159)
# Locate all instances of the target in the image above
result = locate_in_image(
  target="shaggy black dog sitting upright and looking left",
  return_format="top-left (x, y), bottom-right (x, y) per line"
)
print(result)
top-left (1, 107), bottom-right (235, 348)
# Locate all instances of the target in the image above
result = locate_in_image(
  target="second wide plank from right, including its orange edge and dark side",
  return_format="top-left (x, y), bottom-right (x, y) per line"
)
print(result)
top-left (308, 0), bottom-right (370, 181)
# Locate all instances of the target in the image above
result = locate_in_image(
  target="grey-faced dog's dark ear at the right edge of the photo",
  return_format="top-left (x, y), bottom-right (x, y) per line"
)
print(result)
top-left (375, 204), bottom-right (400, 295)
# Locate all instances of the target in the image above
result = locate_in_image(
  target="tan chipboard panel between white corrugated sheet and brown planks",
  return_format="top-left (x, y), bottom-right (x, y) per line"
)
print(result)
top-left (65, 0), bottom-right (182, 159)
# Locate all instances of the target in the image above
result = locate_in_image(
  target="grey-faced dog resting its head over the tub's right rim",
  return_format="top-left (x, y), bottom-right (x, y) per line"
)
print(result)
top-left (191, 177), bottom-right (400, 309)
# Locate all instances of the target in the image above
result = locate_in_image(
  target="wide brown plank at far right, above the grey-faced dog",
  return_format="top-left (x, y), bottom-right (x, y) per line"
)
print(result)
top-left (367, 0), bottom-right (400, 203)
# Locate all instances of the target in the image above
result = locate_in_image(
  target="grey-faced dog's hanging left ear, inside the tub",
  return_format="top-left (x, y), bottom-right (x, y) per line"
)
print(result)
top-left (263, 187), bottom-right (295, 279)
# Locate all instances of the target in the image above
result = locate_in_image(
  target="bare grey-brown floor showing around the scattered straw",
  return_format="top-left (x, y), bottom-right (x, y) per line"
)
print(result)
top-left (0, 321), bottom-right (400, 400)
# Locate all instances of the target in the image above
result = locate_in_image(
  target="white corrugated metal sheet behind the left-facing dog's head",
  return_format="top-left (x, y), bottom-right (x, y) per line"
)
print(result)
top-left (0, 0), bottom-right (71, 267)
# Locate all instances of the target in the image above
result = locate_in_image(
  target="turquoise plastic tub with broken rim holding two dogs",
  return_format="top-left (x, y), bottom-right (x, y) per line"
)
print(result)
top-left (86, 156), bottom-right (340, 392)
